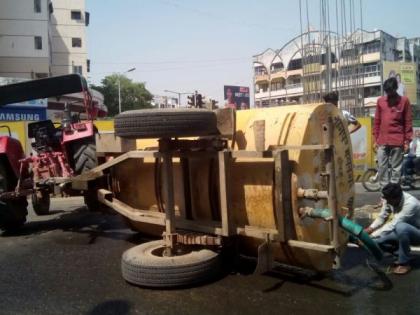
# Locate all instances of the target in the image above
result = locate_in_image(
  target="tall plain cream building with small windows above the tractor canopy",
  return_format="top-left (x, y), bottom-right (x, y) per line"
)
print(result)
top-left (0, 0), bottom-right (89, 79)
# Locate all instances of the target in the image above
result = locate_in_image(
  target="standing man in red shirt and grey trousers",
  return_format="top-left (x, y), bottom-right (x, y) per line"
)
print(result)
top-left (374, 78), bottom-right (413, 187)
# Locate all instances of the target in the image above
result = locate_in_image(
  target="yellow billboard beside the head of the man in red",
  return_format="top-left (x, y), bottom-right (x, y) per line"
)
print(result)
top-left (383, 61), bottom-right (417, 104)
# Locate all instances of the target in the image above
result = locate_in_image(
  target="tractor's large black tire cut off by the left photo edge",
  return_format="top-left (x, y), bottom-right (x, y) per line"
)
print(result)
top-left (0, 160), bottom-right (28, 232)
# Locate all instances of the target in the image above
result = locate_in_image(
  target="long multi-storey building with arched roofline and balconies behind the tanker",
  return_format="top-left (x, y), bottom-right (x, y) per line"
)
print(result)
top-left (253, 30), bottom-right (420, 115)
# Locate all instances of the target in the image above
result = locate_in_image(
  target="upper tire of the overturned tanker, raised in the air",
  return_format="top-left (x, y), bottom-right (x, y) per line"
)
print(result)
top-left (114, 108), bottom-right (218, 139)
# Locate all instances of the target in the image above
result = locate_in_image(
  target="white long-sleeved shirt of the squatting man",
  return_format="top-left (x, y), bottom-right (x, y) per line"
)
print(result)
top-left (370, 192), bottom-right (420, 237)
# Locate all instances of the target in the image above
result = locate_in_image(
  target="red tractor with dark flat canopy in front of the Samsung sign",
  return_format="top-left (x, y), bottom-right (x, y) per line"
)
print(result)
top-left (0, 74), bottom-right (103, 230)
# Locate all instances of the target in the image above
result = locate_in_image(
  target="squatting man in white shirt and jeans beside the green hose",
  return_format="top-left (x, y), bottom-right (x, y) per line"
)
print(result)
top-left (365, 183), bottom-right (420, 275)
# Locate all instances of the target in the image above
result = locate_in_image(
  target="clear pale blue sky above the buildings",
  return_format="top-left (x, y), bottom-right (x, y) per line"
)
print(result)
top-left (86, 0), bottom-right (420, 104)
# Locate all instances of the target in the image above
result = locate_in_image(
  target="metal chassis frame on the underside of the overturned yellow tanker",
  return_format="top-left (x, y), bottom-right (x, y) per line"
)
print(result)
top-left (72, 118), bottom-right (339, 273)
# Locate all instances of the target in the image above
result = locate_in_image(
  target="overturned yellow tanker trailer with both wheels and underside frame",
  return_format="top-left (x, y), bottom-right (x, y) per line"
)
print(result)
top-left (73, 104), bottom-right (378, 287)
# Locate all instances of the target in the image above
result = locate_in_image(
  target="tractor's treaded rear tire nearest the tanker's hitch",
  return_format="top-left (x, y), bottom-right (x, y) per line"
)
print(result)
top-left (73, 138), bottom-right (98, 175)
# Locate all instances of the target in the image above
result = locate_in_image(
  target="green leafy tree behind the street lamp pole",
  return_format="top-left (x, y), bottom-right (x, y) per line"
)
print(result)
top-left (91, 74), bottom-right (153, 117)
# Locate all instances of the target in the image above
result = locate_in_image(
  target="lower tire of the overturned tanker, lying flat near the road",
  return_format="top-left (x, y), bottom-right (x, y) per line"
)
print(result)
top-left (121, 240), bottom-right (221, 288)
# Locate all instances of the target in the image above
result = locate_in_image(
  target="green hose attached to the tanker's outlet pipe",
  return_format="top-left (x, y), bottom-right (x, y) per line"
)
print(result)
top-left (307, 208), bottom-right (383, 260)
